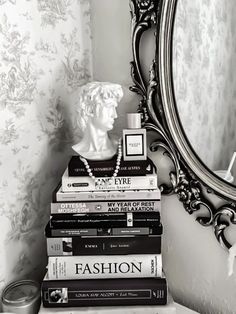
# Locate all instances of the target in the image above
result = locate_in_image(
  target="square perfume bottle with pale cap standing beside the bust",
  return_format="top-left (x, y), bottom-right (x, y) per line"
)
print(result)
top-left (123, 113), bottom-right (147, 160)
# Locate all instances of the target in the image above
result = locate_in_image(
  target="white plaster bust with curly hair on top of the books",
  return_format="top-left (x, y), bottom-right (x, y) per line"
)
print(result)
top-left (72, 82), bottom-right (123, 160)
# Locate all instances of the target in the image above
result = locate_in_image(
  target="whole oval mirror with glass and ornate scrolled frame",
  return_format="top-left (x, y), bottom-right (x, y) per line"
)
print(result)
top-left (130, 0), bottom-right (236, 249)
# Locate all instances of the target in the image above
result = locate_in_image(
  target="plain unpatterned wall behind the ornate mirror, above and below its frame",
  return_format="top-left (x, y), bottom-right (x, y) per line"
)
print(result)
top-left (91, 0), bottom-right (236, 314)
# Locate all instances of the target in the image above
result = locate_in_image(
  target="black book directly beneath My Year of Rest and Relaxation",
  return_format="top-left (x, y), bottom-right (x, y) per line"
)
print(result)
top-left (50, 212), bottom-right (160, 228)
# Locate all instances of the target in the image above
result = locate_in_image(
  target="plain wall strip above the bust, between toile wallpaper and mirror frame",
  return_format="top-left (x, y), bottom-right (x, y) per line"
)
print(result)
top-left (91, 0), bottom-right (137, 134)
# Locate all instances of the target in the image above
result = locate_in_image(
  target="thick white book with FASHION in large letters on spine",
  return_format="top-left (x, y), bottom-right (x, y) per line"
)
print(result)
top-left (48, 254), bottom-right (162, 280)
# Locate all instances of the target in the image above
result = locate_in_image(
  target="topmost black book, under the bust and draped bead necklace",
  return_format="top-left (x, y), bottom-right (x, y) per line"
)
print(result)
top-left (68, 155), bottom-right (156, 177)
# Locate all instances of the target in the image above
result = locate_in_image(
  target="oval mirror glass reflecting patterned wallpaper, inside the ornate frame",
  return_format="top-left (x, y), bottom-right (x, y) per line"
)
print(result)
top-left (172, 0), bottom-right (236, 184)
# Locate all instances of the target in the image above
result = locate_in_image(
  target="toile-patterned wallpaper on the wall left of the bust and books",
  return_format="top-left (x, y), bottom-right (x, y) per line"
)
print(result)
top-left (0, 0), bottom-right (92, 292)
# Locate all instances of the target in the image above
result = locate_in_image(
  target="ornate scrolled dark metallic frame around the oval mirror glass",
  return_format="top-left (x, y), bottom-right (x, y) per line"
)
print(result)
top-left (130, 0), bottom-right (236, 249)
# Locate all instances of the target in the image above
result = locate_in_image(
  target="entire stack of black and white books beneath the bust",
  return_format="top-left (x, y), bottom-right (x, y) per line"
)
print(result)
top-left (42, 156), bottom-right (167, 308)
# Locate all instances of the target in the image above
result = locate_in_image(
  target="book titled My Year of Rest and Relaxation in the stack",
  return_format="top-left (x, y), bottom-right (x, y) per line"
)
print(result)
top-left (51, 200), bottom-right (161, 214)
